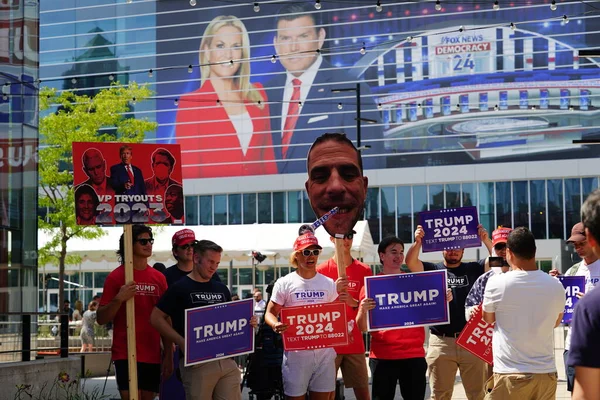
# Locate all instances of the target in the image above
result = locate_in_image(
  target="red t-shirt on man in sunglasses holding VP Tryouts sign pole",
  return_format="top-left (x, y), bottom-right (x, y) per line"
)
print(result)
top-left (100, 265), bottom-right (167, 364)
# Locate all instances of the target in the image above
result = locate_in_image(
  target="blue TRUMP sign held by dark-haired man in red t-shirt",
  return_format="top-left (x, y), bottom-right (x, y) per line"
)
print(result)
top-left (365, 270), bottom-right (450, 331)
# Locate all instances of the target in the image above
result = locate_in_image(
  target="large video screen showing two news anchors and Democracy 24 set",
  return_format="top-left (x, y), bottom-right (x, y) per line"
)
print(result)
top-left (156, 0), bottom-right (600, 179)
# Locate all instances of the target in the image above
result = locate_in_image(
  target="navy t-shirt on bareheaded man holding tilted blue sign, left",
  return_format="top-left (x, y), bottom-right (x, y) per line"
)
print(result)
top-left (156, 276), bottom-right (231, 337)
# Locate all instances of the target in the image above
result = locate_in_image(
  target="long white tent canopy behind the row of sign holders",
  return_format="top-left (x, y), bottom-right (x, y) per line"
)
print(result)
top-left (38, 221), bottom-right (376, 269)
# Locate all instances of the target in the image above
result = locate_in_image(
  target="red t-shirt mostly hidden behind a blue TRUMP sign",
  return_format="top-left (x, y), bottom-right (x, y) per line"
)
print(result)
top-left (359, 282), bottom-right (425, 360)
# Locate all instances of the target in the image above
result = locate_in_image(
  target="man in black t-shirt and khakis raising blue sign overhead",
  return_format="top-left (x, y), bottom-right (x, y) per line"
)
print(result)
top-left (406, 225), bottom-right (492, 400)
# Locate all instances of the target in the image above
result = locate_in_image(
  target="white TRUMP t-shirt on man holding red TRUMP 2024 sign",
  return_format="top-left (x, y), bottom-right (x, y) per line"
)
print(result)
top-left (271, 271), bottom-right (338, 307)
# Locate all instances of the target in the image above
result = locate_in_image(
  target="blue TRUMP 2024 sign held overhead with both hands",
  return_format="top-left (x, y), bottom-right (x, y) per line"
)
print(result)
top-left (419, 207), bottom-right (481, 253)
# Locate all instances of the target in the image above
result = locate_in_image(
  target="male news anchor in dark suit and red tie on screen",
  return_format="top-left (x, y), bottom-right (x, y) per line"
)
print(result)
top-left (266, 3), bottom-right (383, 173)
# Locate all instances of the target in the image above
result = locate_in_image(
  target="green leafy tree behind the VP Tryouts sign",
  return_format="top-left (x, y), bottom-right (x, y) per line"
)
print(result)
top-left (38, 83), bottom-right (157, 307)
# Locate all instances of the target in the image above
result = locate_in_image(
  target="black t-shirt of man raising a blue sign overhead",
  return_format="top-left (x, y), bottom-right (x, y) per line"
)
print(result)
top-left (423, 260), bottom-right (485, 336)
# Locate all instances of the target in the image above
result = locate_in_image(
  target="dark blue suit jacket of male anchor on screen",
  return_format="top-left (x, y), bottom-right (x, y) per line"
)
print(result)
top-left (266, 60), bottom-right (384, 173)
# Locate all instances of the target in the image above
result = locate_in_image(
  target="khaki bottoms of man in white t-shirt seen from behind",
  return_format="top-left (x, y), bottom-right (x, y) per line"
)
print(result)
top-left (485, 372), bottom-right (558, 400)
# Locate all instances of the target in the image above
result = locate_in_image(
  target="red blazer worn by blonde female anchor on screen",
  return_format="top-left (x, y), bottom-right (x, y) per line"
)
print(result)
top-left (175, 80), bottom-right (277, 179)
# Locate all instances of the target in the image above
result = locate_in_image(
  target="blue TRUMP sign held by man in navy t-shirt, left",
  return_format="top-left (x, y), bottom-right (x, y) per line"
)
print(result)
top-left (185, 299), bottom-right (254, 367)
